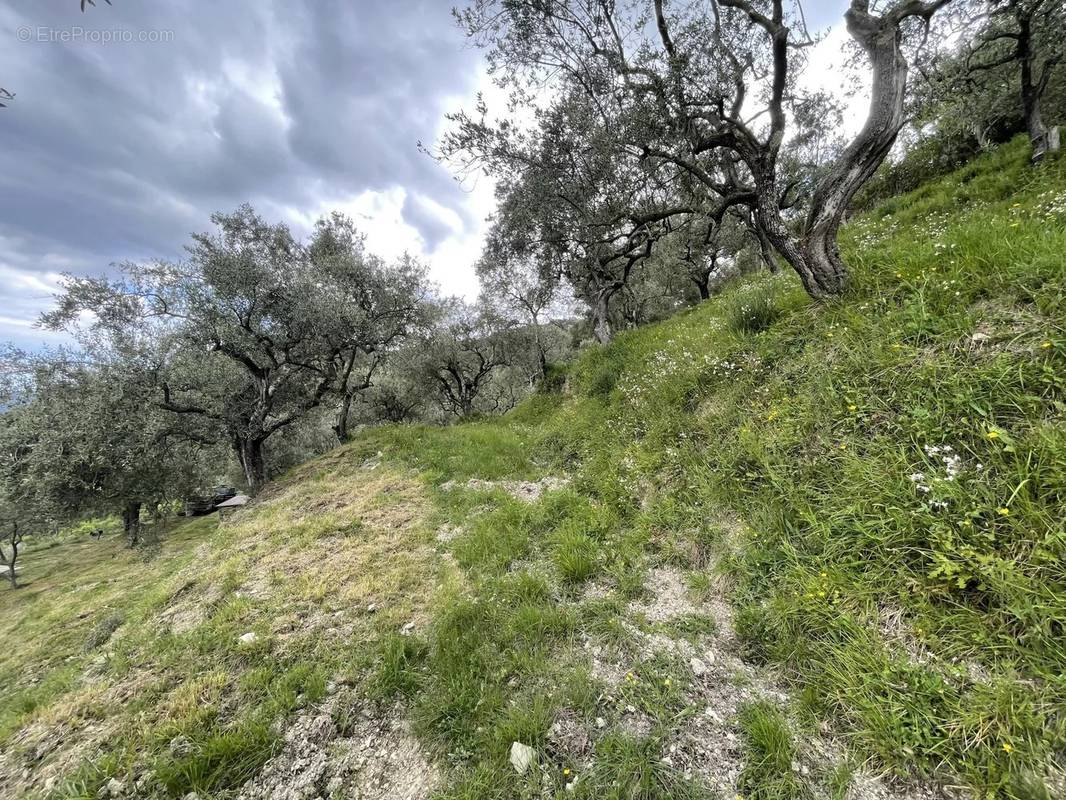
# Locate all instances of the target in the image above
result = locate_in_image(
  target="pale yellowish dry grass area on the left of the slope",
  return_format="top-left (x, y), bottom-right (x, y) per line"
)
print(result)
top-left (0, 450), bottom-right (457, 798)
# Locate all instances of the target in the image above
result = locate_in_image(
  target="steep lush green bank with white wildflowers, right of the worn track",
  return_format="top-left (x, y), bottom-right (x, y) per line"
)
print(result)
top-left (547, 137), bottom-right (1066, 797)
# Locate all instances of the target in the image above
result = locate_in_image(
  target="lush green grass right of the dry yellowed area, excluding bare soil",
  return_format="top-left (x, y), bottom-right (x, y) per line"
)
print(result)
top-left (360, 143), bottom-right (1066, 798)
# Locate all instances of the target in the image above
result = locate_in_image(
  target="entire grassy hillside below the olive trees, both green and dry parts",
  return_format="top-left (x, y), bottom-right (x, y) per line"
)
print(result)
top-left (0, 143), bottom-right (1066, 800)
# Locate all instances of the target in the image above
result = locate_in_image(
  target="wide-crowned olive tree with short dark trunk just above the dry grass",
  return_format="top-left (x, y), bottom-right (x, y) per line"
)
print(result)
top-left (44, 206), bottom-right (340, 492)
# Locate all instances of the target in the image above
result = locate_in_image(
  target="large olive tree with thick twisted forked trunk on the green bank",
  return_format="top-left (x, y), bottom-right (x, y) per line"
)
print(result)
top-left (459, 0), bottom-right (949, 298)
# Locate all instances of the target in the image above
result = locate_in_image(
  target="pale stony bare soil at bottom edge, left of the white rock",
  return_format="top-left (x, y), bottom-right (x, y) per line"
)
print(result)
top-left (238, 691), bottom-right (440, 800)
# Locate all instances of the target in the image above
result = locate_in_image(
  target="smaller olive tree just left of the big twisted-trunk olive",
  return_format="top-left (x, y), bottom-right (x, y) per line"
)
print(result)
top-left (449, 90), bottom-right (707, 342)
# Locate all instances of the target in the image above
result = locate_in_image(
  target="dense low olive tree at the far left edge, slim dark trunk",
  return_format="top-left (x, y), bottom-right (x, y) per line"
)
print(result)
top-left (0, 350), bottom-right (212, 546)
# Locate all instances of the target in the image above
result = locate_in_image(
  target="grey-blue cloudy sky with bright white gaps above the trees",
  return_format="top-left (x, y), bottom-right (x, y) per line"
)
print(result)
top-left (0, 0), bottom-right (846, 347)
